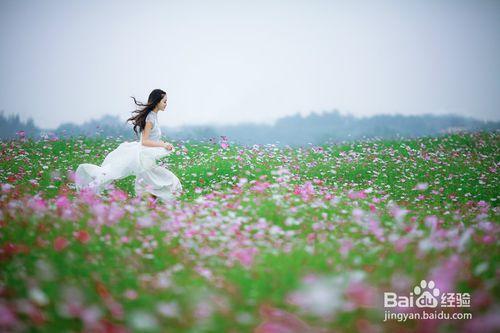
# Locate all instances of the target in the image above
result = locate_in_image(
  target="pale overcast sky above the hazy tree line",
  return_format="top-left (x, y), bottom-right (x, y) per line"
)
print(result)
top-left (0, 0), bottom-right (500, 128)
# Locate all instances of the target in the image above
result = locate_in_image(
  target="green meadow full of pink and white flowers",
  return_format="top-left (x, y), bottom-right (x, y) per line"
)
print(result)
top-left (0, 132), bottom-right (500, 333)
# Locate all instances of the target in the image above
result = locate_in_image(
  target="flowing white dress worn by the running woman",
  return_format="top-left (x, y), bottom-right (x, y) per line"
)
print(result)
top-left (75, 111), bottom-right (182, 200)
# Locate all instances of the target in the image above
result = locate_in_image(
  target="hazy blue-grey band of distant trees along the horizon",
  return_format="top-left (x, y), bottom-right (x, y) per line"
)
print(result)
top-left (0, 109), bottom-right (500, 146)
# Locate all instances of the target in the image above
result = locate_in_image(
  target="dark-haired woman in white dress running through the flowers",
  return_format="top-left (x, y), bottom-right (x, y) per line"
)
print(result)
top-left (75, 89), bottom-right (182, 200)
